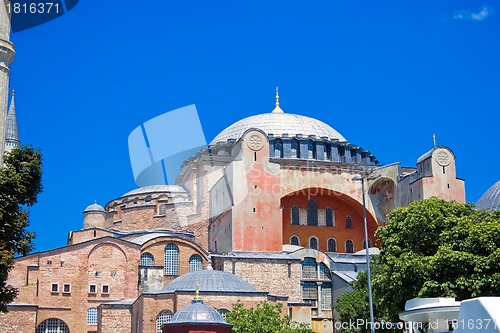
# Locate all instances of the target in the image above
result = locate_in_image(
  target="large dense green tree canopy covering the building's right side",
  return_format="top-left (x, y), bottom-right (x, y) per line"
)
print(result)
top-left (336, 198), bottom-right (500, 321)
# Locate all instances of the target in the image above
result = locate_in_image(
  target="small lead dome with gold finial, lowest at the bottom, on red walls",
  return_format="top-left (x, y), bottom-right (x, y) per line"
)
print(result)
top-left (168, 299), bottom-right (229, 326)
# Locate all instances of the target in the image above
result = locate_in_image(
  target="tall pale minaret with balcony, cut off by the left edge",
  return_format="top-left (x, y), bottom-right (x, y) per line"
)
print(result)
top-left (0, 0), bottom-right (15, 166)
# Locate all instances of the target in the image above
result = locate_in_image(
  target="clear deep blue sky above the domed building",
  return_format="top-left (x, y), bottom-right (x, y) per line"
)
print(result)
top-left (11, 0), bottom-right (500, 251)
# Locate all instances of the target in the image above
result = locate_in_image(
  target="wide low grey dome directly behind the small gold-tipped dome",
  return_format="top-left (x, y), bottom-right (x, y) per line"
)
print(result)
top-left (162, 270), bottom-right (257, 292)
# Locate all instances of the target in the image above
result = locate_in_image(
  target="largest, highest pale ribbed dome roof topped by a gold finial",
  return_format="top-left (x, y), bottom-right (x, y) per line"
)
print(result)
top-left (211, 112), bottom-right (346, 144)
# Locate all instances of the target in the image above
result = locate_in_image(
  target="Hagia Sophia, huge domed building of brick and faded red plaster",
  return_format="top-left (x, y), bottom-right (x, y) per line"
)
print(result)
top-left (0, 4), bottom-right (500, 333)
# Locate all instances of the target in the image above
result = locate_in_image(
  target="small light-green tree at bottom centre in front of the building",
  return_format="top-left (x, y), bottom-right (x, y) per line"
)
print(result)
top-left (226, 301), bottom-right (312, 333)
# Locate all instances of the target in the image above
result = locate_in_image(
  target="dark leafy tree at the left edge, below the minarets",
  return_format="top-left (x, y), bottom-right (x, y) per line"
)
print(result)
top-left (0, 146), bottom-right (42, 312)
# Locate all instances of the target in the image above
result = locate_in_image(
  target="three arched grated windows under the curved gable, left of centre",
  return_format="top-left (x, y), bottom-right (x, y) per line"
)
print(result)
top-left (140, 244), bottom-right (203, 276)
